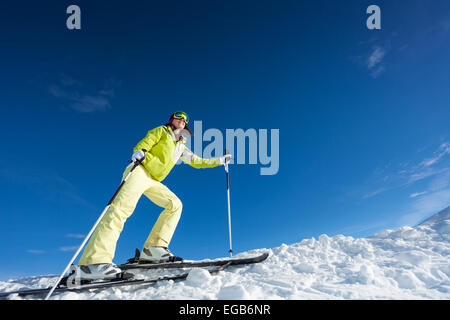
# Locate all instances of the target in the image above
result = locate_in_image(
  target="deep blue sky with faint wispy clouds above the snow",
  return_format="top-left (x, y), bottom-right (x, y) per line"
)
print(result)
top-left (0, 0), bottom-right (450, 280)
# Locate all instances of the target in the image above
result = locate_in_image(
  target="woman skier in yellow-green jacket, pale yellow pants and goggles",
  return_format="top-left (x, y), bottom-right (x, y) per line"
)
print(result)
top-left (73, 111), bottom-right (231, 280)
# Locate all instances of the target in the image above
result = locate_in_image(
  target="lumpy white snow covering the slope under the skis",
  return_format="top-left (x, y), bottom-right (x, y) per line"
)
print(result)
top-left (0, 207), bottom-right (450, 300)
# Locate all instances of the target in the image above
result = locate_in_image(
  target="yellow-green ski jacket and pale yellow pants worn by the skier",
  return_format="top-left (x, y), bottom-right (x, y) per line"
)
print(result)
top-left (78, 125), bottom-right (220, 265)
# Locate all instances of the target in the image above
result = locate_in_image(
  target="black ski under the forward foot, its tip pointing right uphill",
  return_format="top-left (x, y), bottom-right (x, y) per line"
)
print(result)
top-left (118, 252), bottom-right (269, 270)
